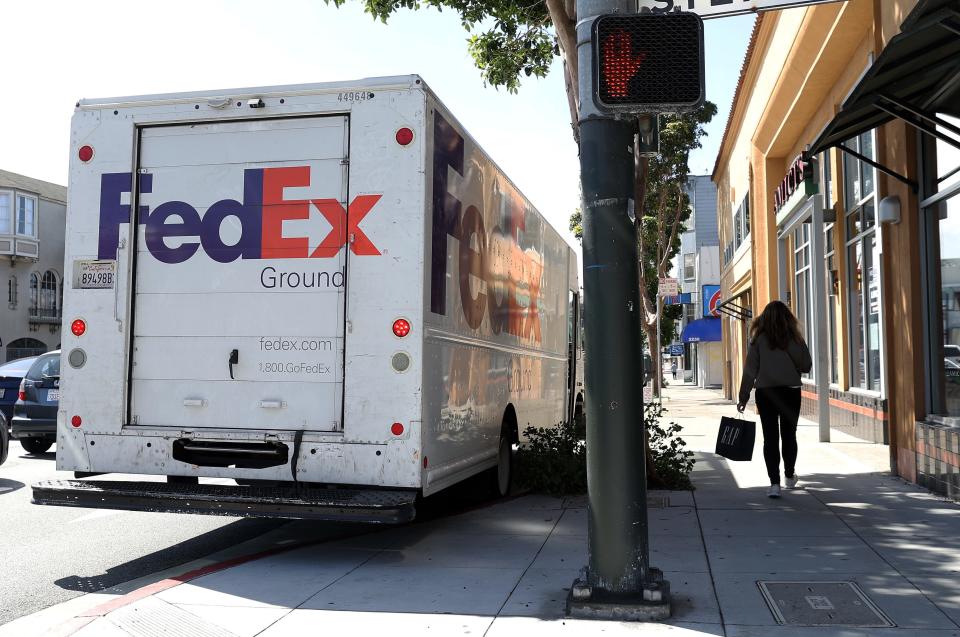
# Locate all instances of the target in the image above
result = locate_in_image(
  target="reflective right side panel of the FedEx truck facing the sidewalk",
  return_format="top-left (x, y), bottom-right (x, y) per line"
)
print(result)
top-left (424, 97), bottom-right (576, 493)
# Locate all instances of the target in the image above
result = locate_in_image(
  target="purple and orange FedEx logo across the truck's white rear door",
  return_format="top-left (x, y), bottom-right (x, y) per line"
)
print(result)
top-left (97, 166), bottom-right (381, 263)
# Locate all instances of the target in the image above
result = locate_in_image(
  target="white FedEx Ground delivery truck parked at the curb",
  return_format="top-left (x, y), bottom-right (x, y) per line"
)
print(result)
top-left (33, 76), bottom-right (583, 522)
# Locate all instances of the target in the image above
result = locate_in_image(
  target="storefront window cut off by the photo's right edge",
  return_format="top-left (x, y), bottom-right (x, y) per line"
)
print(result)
top-left (924, 114), bottom-right (960, 416)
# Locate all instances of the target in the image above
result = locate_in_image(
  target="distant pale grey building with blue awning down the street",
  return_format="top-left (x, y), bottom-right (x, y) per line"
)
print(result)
top-left (674, 175), bottom-right (723, 387)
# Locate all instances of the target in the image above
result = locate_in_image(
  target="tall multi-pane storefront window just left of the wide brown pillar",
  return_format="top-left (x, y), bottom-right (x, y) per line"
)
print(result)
top-left (843, 131), bottom-right (881, 391)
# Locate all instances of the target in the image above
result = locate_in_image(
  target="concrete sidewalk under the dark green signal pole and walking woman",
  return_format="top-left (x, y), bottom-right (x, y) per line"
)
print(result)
top-left (7, 385), bottom-right (960, 637)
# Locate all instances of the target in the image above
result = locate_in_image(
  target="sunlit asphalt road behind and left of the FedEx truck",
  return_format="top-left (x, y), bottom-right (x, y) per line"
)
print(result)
top-left (0, 441), bottom-right (288, 625)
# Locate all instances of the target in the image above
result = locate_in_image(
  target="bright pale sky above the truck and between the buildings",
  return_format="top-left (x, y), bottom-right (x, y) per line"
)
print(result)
top-left (0, 0), bottom-right (754, 258)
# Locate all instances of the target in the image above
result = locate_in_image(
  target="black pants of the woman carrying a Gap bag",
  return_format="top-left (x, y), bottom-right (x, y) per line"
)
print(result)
top-left (757, 387), bottom-right (800, 484)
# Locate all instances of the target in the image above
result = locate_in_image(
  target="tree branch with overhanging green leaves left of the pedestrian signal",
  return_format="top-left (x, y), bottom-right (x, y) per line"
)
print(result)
top-left (324, 0), bottom-right (580, 142)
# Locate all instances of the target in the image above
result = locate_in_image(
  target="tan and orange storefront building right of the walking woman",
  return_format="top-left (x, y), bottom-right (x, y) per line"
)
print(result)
top-left (713, 0), bottom-right (960, 494)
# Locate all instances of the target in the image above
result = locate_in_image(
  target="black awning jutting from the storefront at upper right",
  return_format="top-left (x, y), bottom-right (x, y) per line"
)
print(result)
top-left (809, 0), bottom-right (960, 154)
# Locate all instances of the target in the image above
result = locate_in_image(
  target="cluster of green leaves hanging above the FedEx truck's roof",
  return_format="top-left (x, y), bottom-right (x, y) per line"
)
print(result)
top-left (324, 0), bottom-right (558, 93)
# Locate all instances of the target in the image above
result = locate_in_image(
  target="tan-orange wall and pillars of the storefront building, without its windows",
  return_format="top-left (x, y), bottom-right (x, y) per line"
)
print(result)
top-left (714, 0), bottom-right (924, 480)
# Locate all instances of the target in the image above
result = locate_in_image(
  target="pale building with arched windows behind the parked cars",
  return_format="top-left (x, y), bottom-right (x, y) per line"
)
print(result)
top-left (0, 170), bottom-right (67, 361)
